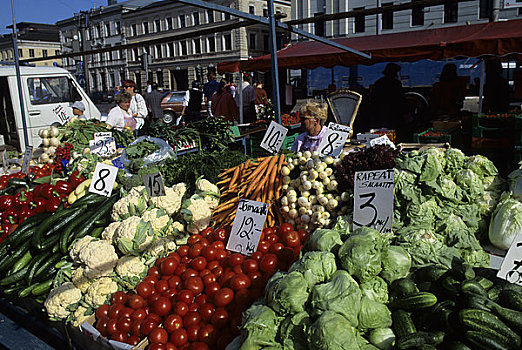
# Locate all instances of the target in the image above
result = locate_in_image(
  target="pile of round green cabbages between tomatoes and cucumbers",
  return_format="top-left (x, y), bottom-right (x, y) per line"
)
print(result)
top-left (236, 227), bottom-right (411, 350)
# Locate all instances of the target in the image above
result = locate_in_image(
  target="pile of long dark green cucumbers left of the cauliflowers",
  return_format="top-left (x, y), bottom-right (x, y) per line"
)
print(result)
top-left (0, 192), bottom-right (119, 302)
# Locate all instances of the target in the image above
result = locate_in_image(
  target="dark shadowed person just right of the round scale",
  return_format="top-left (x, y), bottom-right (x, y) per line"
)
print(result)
top-left (370, 63), bottom-right (407, 131)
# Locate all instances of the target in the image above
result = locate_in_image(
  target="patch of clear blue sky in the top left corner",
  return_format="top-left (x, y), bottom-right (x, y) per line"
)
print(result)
top-left (0, 0), bottom-right (101, 34)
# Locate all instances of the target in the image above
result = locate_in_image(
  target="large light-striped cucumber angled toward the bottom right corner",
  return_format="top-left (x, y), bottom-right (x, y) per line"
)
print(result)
top-left (459, 309), bottom-right (520, 348)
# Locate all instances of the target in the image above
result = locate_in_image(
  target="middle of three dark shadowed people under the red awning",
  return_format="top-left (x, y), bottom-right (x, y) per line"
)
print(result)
top-left (431, 63), bottom-right (466, 118)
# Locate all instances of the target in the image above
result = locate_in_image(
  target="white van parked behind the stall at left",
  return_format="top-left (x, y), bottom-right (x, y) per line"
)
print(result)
top-left (0, 66), bottom-right (101, 152)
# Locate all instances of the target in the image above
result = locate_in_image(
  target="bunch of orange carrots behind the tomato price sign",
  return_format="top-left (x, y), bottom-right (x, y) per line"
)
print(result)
top-left (212, 154), bottom-right (286, 227)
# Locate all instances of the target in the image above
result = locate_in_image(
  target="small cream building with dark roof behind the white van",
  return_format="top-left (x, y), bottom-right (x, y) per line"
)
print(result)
top-left (0, 22), bottom-right (61, 66)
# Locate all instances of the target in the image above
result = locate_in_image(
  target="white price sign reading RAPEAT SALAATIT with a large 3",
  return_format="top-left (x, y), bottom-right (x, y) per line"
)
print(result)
top-left (353, 169), bottom-right (393, 233)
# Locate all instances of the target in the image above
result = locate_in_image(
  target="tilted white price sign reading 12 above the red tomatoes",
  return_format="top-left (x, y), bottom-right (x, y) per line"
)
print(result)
top-left (227, 199), bottom-right (268, 255)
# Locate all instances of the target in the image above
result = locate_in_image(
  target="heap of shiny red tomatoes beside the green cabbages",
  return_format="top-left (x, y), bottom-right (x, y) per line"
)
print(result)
top-left (95, 223), bottom-right (308, 350)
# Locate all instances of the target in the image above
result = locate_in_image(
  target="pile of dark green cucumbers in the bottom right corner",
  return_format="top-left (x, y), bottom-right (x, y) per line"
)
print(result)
top-left (388, 259), bottom-right (522, 350)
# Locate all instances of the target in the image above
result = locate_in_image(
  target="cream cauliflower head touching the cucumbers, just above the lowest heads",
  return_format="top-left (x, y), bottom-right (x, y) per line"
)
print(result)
top-left (78, 240), bottom-right (118, 278)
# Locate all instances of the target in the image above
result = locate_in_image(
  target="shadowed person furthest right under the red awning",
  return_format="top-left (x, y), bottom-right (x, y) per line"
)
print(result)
top-left (483, 60), bottom-right (509, 113)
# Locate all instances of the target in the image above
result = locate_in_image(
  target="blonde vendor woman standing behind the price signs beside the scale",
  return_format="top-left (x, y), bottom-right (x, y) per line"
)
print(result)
top-left (292, 101), bottom-right (328, 152)
